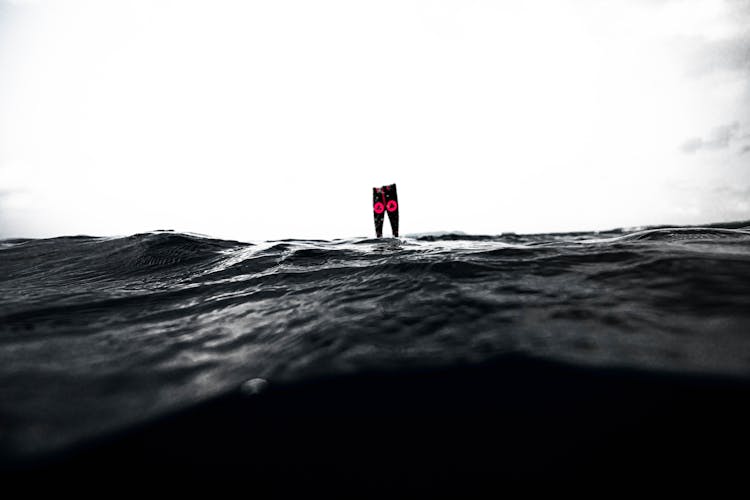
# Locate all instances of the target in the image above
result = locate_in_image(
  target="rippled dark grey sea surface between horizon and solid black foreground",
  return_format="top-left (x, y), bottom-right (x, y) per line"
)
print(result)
top-left (0, 222), bottom-right (750, 484)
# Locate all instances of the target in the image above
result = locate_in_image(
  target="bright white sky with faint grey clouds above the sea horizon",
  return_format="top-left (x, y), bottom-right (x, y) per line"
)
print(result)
top-left (0, 0), bottom-right (750, 240)
